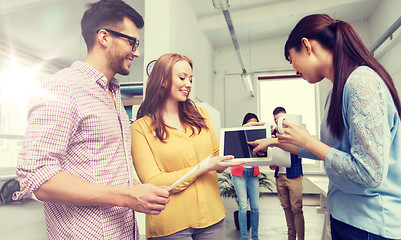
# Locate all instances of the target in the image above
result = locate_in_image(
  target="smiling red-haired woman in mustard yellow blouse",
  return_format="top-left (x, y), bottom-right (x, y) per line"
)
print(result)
top-left (131, 53), bottom-right (243, 240)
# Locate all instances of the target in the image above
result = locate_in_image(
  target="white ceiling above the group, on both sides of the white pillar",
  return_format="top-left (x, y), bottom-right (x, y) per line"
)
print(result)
top-left (0, 0), bottom-right (385, 67)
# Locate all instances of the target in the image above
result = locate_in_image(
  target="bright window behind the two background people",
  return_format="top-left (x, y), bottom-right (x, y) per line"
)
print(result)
top-left (258, 75), bottom-right (323, 173)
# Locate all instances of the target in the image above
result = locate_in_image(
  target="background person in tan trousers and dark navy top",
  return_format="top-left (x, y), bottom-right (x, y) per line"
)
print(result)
top-left (270, 107), bottom-right (305, 240)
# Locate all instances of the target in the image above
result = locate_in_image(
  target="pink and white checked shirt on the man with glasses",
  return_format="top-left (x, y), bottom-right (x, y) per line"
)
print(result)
top-left (14, 62), bottom-right (139, 240)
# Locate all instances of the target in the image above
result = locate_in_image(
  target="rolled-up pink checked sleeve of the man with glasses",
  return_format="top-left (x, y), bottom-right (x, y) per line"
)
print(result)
top-left (14, 80), bottom-right (78, 199)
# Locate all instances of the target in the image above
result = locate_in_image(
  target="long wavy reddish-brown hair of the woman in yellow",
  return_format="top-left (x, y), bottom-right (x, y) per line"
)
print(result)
top-left (137, 53), bottom-right (208, 142)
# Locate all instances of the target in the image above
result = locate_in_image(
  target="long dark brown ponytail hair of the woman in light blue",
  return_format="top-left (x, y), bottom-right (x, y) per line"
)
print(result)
top-left (284, 14), bottom-right (401, 138)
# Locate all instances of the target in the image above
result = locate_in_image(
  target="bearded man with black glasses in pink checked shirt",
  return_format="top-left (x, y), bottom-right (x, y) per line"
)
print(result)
top-left (14, 0), bottom-right (169, 240)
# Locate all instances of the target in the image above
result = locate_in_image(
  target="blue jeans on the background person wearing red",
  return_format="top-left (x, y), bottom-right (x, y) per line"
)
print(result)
top-left (232, 168), bottom-right (259, 240)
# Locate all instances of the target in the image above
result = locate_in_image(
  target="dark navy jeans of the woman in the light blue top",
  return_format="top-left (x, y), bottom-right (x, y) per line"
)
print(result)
top-left (330, 215), bottom-right (395, 240)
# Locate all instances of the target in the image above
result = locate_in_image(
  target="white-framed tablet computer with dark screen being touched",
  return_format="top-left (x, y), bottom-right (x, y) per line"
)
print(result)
top-left (219, 126), bottom-right (272, 166)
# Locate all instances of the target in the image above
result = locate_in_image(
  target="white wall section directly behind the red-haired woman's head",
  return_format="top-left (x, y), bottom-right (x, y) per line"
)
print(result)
top-left (144, 0), bottom-right (214, 103)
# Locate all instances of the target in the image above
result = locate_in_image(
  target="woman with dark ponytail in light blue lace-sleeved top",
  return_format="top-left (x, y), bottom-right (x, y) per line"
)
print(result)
top-left (248, 14), bottom-right (401, 240)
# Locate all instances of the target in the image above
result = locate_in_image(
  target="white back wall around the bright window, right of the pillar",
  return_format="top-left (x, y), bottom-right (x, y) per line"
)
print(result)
top-left (215, 36), bottom-right (331, 127)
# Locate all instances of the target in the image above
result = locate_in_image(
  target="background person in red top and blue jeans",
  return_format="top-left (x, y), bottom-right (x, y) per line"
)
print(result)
top-left (231, 113), bottom-right (260, 240)
